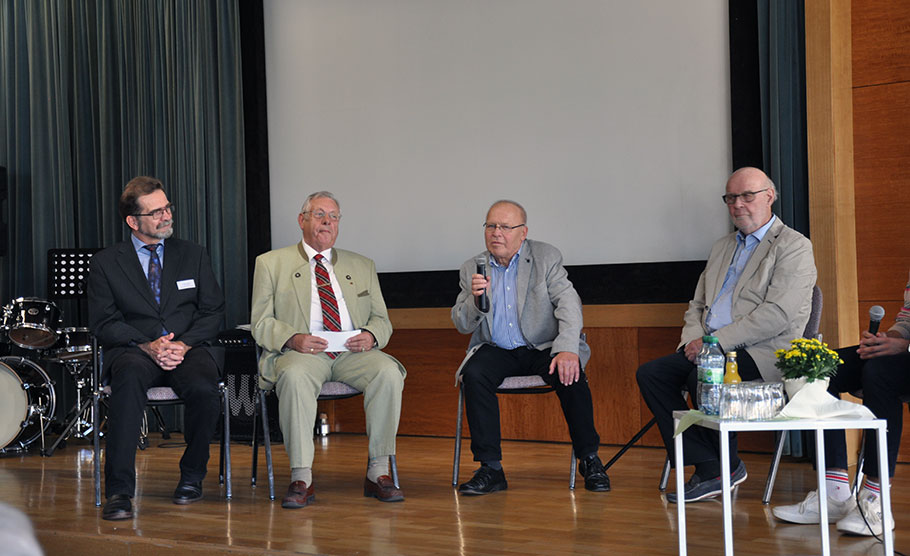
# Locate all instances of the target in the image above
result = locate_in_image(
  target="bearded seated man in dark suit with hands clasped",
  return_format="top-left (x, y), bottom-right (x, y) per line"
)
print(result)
top-left (88, 177), bottom-right (224, 520)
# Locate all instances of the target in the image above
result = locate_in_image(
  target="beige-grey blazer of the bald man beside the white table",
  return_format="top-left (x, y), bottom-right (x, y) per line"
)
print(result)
top-left (679, 218), bottom-right (816, 381)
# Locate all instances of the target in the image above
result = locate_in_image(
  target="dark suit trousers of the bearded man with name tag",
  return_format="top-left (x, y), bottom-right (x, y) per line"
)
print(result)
top-left (104, 347), bottom-right (221, 498)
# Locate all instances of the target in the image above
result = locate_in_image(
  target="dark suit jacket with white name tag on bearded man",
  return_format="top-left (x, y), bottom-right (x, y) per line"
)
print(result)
top-left (88, 239), bottom-right (224, 369)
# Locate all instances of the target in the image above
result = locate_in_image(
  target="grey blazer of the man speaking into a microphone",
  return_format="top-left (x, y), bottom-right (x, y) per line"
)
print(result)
top-left (452, 239), bottom-right (591, 376)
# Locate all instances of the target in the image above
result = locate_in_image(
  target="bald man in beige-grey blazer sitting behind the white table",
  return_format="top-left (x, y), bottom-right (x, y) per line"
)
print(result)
top-left (636, 168), bottom-right (816, 502)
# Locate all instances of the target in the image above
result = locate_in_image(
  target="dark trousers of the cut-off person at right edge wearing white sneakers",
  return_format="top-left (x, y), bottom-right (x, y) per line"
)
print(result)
top-left (825, 346), bottom-right (910, 477)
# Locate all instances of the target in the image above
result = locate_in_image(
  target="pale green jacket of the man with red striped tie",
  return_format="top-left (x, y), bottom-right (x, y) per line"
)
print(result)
top-left (250, 243), bottom-right (400, 382)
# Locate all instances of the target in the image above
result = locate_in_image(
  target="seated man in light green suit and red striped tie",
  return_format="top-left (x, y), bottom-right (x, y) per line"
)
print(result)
top-left (251, 191), bottom-right (405, 508)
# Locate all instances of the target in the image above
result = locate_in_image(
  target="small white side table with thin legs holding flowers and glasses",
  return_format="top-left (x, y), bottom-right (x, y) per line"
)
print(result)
top-left (673, 411), bottom-right (894, 556)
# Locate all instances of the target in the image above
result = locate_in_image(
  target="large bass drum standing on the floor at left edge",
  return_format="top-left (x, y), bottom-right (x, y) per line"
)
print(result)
top-left (0, 357), bottom-right (57, 452)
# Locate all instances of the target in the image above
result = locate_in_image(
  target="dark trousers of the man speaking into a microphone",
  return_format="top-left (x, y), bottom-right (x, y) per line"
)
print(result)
top-left (461, 344), bottom-right (600, 461)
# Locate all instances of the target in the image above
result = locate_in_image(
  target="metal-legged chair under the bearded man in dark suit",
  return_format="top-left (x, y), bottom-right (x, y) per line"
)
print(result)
top-left (92, 337), bottom-right (233, 506)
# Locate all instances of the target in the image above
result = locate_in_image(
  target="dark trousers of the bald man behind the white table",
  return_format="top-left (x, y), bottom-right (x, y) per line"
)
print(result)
top-left (635, 349), bottom-right (761, 469)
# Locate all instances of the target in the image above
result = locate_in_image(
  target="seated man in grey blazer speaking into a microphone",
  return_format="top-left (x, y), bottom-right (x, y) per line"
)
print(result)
top-left (452, 201), bottom-right (610, 495)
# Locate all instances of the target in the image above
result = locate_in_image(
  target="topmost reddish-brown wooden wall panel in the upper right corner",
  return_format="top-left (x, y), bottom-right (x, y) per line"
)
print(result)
top-left (852, 0), bottom-right (910, 87)
